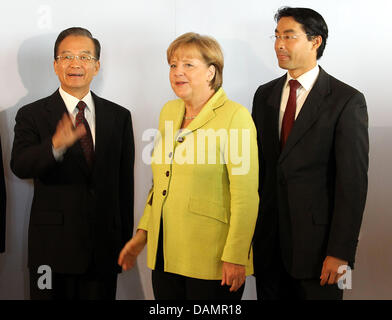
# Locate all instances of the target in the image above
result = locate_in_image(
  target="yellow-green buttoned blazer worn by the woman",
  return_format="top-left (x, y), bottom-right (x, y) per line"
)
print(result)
top-left (138, 88), bottom-right (259, 280)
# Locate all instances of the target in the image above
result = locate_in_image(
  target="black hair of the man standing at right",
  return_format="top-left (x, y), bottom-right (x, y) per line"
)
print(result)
top-left (275, 7), bottom-right (328, 59)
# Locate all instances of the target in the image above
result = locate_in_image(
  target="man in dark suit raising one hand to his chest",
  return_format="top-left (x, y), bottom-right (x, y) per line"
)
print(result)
top-left (11, 28), bottom-right (134, 299)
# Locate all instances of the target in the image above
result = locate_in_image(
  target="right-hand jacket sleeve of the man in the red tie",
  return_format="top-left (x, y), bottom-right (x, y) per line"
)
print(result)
top-left (327, 92), bottom-right (369, 263)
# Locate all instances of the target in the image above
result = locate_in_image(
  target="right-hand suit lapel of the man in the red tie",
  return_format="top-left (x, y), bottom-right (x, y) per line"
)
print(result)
top-left (279, 67), bottom-right (330, 162)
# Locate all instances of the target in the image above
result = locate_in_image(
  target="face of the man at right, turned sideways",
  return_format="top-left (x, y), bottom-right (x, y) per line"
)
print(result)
top-left (275, 17), bottom-right (321, 78)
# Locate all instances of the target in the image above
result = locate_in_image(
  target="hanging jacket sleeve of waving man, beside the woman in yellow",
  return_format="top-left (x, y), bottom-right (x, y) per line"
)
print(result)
top-left (119, 112), bottom-right (135, 244)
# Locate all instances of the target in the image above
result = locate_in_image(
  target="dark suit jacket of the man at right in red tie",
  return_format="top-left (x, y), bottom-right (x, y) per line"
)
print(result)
top-left (252, 68), bottom-right (369, 279)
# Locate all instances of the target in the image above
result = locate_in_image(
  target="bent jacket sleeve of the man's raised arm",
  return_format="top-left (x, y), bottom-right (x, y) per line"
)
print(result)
top-left (11, 107), bottom-right (56, 179)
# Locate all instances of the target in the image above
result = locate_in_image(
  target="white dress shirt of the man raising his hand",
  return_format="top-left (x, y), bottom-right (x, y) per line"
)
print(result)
top-left (53, 87), bottom-right (95, 161)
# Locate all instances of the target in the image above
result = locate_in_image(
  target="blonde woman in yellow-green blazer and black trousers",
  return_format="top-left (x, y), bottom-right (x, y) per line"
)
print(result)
top-left (118, 33), bottom-right (259, 300)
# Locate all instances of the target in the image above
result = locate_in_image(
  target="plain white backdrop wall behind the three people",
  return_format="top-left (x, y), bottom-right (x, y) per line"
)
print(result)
top-left (0, 0), bottom-right (392, 299)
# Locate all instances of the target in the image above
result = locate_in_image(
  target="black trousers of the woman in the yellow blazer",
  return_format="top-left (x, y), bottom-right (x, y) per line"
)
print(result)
top-left (152, 270), bottom-right (245, 300)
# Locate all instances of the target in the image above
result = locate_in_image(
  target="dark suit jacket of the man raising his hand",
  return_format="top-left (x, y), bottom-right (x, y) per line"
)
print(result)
top-left (11, 91), bottom-right (134, 274)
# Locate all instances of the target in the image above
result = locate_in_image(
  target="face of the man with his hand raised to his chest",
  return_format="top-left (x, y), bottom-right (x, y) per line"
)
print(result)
top-left (54, 36), bottom-right (100, 99)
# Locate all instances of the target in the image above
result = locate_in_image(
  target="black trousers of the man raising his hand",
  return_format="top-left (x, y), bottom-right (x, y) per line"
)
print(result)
top-left (30, 268), bottom-right (117, 300)
